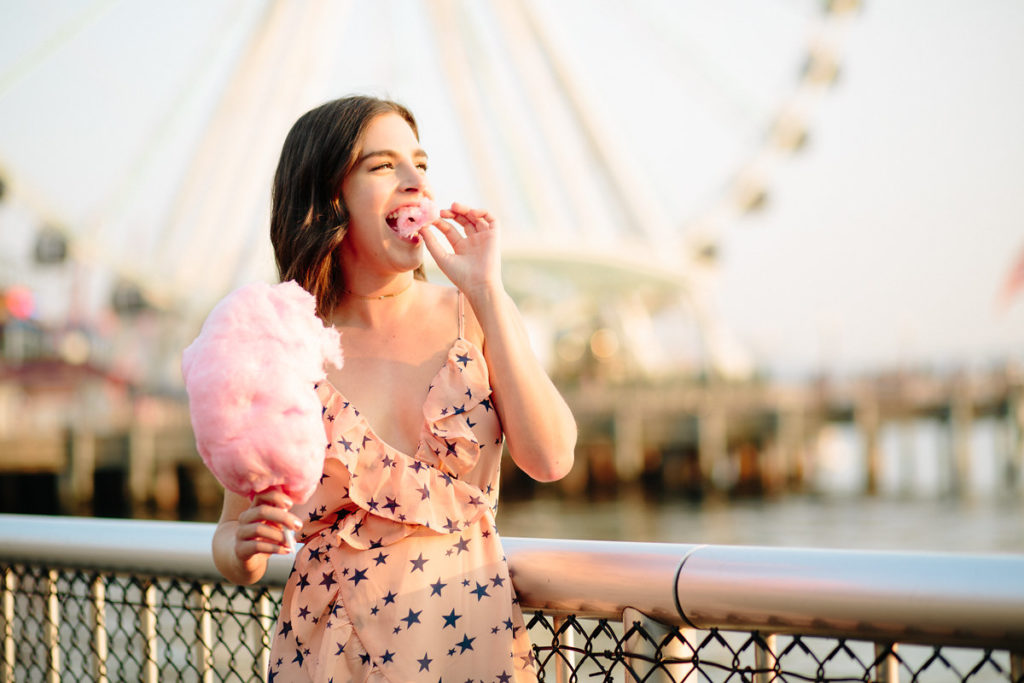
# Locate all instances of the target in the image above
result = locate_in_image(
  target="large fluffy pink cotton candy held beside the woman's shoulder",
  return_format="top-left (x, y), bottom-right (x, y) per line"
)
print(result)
top-left (181, 281), bottom-right (342, 503)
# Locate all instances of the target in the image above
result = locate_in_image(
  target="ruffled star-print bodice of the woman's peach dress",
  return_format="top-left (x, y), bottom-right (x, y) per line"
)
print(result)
top-left (302, 337), bottom-right (494, 549)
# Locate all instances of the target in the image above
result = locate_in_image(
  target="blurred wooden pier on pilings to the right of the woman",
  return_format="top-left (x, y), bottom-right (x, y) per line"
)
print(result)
top-left (563, 366), bottom-right (1024, 496)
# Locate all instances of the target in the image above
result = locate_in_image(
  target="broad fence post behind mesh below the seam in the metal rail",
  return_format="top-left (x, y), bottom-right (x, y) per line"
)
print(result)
top-left (623, 607), bottom-right (694, 683)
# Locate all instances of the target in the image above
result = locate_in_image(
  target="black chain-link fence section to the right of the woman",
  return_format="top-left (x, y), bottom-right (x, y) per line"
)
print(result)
top-left (528, 612), bottom-right (1024, 683)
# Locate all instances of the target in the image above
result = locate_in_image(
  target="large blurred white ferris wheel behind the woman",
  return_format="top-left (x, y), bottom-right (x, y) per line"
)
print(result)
top-left (0, 0), bottom-right (859, 385)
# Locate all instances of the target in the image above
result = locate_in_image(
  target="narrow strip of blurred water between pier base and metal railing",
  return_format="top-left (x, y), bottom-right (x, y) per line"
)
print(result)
top-left (498, 494), bottom-right (1024, 553)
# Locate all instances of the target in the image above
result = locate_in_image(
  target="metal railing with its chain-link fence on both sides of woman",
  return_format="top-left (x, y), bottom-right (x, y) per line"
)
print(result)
top-left (0, 515), bottom-right (1024, 683)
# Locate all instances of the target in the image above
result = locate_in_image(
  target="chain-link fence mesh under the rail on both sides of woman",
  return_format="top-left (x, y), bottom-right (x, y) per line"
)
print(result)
top-left (0, 564), bottom-right (1024, 683)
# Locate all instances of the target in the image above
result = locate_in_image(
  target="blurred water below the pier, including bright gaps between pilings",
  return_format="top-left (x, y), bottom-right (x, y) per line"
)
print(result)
top-left (498, 419), bottom-right (1024, 553)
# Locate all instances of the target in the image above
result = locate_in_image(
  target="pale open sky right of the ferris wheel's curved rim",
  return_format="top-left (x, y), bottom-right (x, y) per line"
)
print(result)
top-left (721, 0), bottom-right (1024, 370)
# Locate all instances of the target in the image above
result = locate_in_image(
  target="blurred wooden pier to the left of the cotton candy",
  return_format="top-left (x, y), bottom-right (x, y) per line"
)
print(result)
top-left (0, 359), bottom-right (211, 517)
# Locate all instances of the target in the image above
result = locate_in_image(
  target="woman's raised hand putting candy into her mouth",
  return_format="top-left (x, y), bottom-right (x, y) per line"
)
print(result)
top-left (420, 198), bottom-right (501, 295)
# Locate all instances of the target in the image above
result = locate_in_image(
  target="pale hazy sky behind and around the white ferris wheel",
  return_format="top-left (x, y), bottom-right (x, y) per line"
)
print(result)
top-left (0, 0), bottom-right (1024, 374)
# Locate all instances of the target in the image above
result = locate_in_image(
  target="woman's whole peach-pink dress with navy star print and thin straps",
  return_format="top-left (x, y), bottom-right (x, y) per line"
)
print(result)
top-left (268, 295), bottom-right (537, 683)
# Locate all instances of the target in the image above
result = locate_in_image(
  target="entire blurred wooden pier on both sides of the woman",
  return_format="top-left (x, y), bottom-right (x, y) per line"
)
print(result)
top-left (0, 361), bottom-right (1024, 517)
